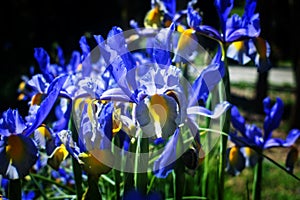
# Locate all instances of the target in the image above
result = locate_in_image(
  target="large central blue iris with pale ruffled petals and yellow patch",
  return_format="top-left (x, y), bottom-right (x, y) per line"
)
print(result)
top-left (94, 25), bottom-right (230, 177)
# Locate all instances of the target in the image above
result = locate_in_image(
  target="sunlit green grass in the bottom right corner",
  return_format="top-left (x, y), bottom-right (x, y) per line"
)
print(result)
top-left (225, 154), bottom-right (300, 200)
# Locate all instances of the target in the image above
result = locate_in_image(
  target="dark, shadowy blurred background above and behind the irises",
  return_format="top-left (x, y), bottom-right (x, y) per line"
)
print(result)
top-left (0, 0), bottom-right (300, 130)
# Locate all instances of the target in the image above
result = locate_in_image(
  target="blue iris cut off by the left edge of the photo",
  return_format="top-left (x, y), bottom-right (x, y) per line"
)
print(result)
top-left (0, 109), bottom-right (38, 179)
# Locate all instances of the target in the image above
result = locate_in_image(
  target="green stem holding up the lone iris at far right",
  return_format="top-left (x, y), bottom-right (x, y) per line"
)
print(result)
top-left (252, 156), bottom-right (263, 200)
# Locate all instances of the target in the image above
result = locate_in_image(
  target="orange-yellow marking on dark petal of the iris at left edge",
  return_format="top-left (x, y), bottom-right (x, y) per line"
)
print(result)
top-left (5, 135), bottom-right (25, 162)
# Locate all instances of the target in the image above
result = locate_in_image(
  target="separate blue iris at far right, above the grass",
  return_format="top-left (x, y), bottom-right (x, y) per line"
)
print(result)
top-left (229, 97), bottom-right (300, 175)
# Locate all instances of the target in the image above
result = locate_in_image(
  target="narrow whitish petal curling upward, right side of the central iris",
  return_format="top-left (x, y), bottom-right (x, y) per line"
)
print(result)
top-left (187, 101), bottom-right (231, 119)
